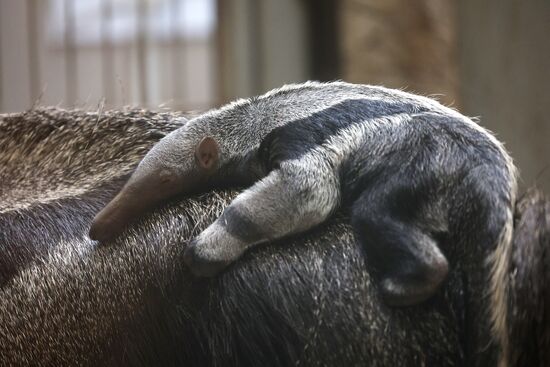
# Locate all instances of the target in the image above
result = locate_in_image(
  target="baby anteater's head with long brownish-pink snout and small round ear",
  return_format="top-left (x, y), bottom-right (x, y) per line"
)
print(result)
top-left (90, 123), bottom-right (220, 242)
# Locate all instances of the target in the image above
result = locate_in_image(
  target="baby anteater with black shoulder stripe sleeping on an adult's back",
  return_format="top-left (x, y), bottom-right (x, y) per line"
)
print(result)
top-left (91, 82), bottom-right (516, 323)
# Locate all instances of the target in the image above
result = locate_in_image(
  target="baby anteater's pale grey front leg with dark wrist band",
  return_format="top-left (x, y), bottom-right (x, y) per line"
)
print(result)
top-left (184, 161), bottom-right (340, 276)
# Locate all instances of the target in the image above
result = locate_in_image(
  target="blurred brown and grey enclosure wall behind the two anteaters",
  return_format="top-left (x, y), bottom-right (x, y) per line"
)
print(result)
top-left (0, 0), bottom-right (550, 193)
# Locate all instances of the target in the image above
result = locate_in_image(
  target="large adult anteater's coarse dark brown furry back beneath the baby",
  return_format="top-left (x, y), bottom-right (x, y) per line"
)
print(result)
top-left (0, 109), bottom-right (550, 366)
